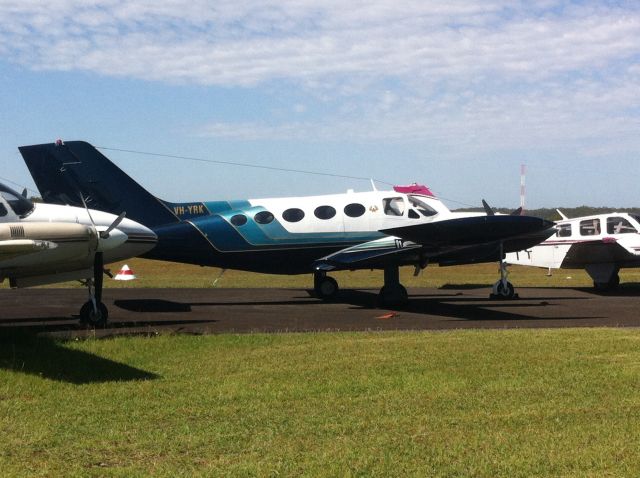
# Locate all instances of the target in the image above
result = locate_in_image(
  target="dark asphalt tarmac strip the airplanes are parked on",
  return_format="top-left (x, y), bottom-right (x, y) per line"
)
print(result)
top-left (0, 287), bottom-right (640, 338)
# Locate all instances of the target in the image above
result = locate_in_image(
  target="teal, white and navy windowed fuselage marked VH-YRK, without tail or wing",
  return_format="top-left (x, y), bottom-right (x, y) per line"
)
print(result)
top-left (145, 186), bottom-right (484, 274)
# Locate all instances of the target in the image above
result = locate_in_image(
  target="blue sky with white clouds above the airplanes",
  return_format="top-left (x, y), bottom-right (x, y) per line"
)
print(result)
top-left (0, 0), bottom-right (640, 208)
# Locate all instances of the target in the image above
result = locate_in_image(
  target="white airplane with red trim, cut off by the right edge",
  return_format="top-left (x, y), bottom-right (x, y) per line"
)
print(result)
top-left (506, 211), bottom-right (640, 290)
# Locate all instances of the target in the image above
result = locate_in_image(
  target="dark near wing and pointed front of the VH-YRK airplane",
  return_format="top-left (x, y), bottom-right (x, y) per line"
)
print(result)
top-left (314, 216), bottom-right (555, 271)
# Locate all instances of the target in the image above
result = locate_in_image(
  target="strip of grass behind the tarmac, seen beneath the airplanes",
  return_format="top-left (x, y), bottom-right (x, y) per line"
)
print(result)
top-left (5, 258), bottom-right (640, 288)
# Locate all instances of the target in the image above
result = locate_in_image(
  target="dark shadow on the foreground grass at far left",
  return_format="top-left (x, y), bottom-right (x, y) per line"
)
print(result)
top-left (0, 328), bottom-right (159, 385)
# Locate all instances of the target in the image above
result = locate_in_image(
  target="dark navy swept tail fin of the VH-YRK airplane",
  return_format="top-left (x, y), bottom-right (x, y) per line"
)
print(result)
top-left (18, 141), bottom-right (178, 227)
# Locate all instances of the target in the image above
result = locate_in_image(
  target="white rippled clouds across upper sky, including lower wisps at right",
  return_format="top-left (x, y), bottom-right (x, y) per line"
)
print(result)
top-left (0, 0), bottom-right (640, 151)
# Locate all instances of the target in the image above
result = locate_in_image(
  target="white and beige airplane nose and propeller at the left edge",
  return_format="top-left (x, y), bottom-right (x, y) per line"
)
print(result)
top-left (0, 184), bottom-right (157, 325)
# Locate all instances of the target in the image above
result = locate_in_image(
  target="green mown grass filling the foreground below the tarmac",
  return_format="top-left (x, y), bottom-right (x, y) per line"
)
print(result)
top-left (0, 329), bottom-right (640, 477)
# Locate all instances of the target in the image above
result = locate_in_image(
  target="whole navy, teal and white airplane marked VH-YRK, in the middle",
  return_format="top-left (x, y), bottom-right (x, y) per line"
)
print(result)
top-left (19, 141), bottom-right (555, 305)
